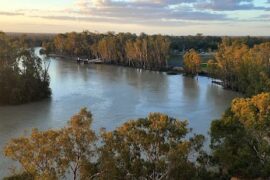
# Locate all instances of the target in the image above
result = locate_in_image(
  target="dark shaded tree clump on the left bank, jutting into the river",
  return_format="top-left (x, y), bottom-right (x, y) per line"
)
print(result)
top-left (0, 33), bottom-right (51, 104)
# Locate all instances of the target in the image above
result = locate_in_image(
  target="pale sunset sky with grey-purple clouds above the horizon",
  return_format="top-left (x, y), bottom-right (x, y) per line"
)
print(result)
top-left (0, 0), bottom-right (270, 36)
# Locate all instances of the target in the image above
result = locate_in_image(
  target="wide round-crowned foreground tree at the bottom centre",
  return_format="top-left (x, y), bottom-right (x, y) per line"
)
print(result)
top-left (99, 113), bottom-right (207, 179)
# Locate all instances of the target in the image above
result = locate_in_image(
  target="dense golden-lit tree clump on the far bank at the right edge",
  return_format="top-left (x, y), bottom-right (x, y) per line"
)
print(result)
top-left (209, 38), bottom-right (270, 96)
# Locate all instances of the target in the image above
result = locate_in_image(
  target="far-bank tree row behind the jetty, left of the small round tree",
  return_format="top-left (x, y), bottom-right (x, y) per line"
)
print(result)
top-left (43, 31), bottom-right (269, 70)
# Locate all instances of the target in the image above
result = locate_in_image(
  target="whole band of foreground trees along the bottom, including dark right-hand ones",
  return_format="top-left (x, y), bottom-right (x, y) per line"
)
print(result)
top-left (4, 93), bottom-right (270, 179)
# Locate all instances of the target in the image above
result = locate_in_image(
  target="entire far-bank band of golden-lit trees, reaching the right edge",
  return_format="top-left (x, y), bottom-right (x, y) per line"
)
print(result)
top-left (3, 31), bottom-right (270, 96)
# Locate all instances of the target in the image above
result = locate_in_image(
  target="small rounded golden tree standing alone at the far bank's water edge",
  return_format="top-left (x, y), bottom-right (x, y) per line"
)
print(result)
top-left (184, 49), bottom-right (201, 76)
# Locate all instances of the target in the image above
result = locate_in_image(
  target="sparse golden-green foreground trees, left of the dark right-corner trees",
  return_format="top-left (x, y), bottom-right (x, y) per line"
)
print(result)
top-left (4, 109), bottom-right (213, 179)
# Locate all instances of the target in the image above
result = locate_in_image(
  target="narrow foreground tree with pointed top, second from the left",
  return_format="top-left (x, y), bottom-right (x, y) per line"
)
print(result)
top-left (60, 108), bottom-right (97, 180)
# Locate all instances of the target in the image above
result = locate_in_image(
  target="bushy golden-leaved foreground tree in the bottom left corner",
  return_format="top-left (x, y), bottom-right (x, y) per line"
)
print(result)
top-left (4, 129), bottom-right (64, 179)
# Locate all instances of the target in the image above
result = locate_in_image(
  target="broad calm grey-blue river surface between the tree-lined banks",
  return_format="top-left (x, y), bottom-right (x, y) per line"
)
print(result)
top-left (0, 55), bottom-right (238, 177)
